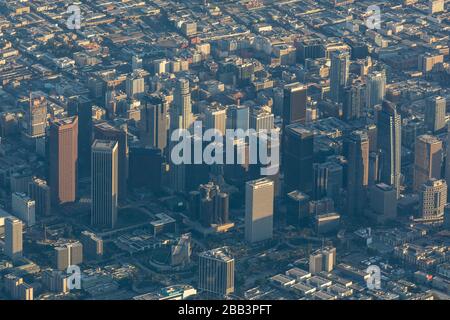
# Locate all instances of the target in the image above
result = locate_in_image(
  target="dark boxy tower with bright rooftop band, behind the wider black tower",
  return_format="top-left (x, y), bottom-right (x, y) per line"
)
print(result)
top-left (283, 82), bottom-right (308, 126)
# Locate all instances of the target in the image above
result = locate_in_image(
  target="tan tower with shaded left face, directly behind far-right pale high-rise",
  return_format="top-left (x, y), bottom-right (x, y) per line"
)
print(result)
top-left (414, 134), bottom-right (442, 192)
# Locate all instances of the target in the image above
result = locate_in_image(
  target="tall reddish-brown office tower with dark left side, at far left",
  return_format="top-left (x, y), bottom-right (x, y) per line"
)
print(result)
top-left (49, 116), bottom-right (78, 205)
